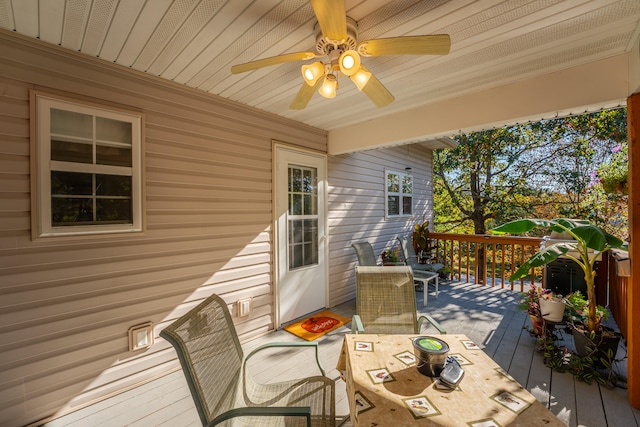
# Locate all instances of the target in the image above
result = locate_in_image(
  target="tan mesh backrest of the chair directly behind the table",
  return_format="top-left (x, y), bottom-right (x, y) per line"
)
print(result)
top-left (356, 266), bottom-right (420, 334)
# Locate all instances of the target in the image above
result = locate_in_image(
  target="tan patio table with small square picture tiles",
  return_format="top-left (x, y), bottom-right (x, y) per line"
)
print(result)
top-left (336, 334), bottom-right (565, 427)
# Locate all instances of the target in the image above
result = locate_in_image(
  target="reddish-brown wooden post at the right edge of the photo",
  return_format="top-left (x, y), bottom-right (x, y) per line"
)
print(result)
top-left (627, 93), bottom-right (640, 409)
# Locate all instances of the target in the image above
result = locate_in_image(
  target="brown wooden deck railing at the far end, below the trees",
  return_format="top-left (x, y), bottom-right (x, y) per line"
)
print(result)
top-left (429, 233), bottom-right (544, 291)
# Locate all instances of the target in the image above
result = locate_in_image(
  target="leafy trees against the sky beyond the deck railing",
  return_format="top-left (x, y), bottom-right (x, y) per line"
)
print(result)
top-left (434, 109), bottom-right (626, 234)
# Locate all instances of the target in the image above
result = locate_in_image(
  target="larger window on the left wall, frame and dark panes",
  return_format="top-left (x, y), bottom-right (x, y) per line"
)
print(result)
top-left (32, 92), bottom-right (142, 237)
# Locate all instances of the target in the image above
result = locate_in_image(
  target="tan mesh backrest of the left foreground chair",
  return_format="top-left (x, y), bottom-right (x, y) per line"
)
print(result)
top-left (160, 295), bottom-right (244, 425)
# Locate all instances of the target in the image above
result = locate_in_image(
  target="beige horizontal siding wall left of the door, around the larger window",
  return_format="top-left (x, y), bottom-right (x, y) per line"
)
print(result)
top-left (0, 32), bottom-right (326, 425)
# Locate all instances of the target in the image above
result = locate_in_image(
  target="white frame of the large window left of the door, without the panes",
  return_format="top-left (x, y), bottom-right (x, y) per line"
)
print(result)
top-left (31, 91), bottom-right (144, 238)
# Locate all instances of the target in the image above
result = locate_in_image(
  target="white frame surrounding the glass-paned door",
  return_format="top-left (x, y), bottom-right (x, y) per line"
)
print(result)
top-left (271, 140), bottom-right (329, 329)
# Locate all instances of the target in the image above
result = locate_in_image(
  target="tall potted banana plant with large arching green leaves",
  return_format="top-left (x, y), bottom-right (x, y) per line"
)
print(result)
top-left (491, 218), bottom-right (624, 356)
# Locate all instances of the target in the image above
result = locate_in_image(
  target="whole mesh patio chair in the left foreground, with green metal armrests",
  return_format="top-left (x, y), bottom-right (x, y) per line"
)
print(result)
top-left (160, 295), bottom-right (335, 427)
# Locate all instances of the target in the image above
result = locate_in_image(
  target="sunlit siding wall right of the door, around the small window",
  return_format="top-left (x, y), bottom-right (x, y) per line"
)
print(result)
top-left (328, 144), bottom-right (433, 306)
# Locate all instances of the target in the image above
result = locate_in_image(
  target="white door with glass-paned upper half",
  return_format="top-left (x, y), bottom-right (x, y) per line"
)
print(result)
top-left (274, 145), bottom-right (327, 327)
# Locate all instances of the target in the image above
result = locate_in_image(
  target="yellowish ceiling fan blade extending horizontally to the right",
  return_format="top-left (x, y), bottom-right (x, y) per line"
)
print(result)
top-left (358, 34), bottom-right (451, 56)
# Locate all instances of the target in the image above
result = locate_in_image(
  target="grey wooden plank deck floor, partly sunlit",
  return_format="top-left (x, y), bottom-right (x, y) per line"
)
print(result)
top-left (44, 283), bottom-right (640, 427)
